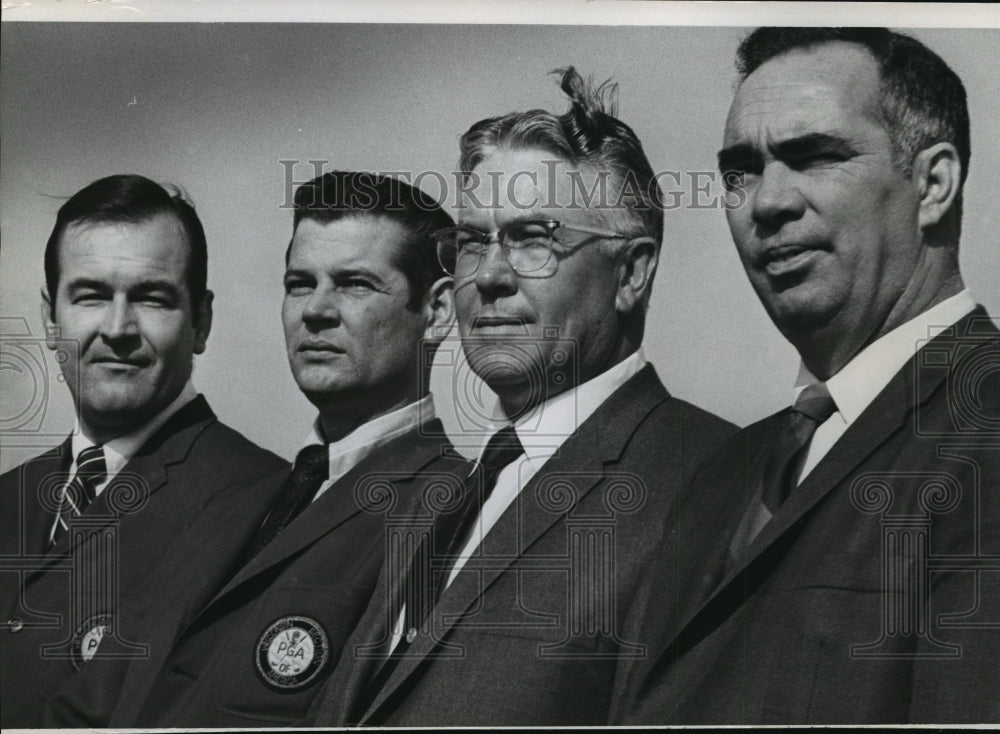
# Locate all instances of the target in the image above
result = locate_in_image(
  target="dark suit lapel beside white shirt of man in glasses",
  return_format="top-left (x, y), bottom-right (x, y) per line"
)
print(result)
top-left (362, 365), bottom-right (669, 720)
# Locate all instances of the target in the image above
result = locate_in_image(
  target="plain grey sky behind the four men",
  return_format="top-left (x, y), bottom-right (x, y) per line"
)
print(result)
top-left (0, 22), bottom-right (1000, 470)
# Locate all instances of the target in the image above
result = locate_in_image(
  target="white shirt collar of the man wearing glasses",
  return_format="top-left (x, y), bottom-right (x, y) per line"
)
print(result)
top-left (479, 347), bottom-right (647, 460)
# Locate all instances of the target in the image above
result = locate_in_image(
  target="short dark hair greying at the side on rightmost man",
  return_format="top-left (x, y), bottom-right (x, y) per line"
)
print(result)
top-left (736, 27), bottom-right (971, 226)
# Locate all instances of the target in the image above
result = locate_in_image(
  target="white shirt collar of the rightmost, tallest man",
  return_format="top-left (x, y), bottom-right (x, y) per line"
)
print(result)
top-left (795, 290), bottom-right (976, 424)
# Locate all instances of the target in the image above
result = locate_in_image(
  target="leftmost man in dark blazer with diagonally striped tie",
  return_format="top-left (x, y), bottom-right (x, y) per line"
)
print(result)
top-left (0, 176), bottom-right (287, 727)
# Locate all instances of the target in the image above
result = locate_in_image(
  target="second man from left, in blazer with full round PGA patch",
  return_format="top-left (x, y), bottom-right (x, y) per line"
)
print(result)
top-left (48, 172), bottom-right (470, 727)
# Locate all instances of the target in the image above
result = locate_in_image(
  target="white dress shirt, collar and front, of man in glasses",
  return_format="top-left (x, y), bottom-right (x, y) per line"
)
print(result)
top-left (390, 348), bottom-right (646, 649)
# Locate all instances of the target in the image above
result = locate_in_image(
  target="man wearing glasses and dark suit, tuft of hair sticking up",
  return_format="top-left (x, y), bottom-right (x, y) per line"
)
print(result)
top-left (314, 69), bottom-right (731, 726)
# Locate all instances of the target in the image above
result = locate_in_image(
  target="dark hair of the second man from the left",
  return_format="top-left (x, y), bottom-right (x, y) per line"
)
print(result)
top-left (285, 171), bottom-right (455, 309)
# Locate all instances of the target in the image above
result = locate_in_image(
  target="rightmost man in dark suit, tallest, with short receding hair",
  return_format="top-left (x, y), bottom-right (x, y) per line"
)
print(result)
top-left (615, 28), bottom-right (1000, 724)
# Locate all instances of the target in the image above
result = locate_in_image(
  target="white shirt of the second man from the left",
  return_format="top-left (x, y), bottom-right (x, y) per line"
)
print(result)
top-left (302, 395), bottom-right (434, 502)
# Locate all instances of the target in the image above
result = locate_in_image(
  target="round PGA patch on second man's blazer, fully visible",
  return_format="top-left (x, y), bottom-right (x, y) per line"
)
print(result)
top-left (254, 617), bottom-right (330, 691)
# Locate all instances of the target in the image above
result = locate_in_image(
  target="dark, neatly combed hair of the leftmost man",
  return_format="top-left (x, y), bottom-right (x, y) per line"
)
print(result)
top-left (45, 174), bottom-right (208, 313)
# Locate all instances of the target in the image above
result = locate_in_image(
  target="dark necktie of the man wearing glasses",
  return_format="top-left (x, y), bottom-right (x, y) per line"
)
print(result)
top-left (358, 426), bottom-right (524, 713)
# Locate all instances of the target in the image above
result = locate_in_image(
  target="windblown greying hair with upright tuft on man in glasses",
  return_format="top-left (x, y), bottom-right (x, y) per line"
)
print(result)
top-left (458, 66), bottom-right (663, 256)
